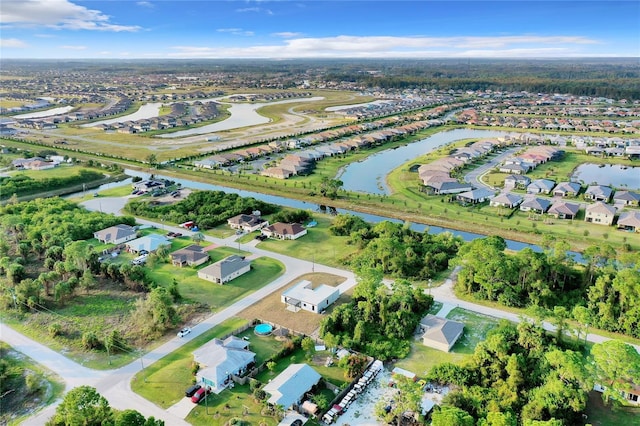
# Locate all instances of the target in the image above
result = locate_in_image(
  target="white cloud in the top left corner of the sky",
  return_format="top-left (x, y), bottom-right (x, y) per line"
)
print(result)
top-left (0, 0), bottom-right (140, 32)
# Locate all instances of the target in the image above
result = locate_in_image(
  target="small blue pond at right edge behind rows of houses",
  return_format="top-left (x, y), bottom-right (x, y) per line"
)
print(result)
top-left (571, 163), bottom-right (640, 190)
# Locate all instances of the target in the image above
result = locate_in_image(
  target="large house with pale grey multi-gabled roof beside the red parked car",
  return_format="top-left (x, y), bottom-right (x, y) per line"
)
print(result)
top-left (193, 336), bottom-right (256, 393)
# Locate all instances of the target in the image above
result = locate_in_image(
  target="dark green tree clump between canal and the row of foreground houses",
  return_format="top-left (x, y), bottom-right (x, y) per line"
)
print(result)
top-left (125, 191), bottom-right (278, 229)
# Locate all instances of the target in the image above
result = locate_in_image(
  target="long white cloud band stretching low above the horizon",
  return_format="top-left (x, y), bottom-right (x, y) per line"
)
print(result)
top-left (169, 34), bottom-right (599, 58)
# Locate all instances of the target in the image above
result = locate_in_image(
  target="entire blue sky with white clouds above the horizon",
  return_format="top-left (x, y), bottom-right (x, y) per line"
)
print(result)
top-left (0, 0), bottom-right (640, 59)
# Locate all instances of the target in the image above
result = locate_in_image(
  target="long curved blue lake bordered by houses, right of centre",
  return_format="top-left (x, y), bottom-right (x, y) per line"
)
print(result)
top-left (338, 129), bottom-right (508, 195)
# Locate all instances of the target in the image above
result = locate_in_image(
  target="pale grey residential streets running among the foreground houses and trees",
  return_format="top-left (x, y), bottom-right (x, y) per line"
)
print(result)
top-left (0, 197), bottom-right (640, 426)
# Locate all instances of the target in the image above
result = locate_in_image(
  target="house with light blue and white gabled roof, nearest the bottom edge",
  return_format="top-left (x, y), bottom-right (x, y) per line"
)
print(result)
top-left (262, 364), bottom-right (322, 410)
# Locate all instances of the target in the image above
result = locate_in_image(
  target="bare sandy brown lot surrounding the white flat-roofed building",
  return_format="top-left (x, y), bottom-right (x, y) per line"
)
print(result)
top-left (238, 272), bottom-right (349, 336)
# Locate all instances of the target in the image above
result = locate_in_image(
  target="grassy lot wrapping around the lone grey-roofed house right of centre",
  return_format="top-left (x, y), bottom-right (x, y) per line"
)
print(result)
top-left (395, 308), bottom-right (498, 377)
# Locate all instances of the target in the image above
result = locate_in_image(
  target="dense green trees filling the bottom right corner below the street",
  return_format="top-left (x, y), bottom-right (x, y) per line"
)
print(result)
top-left (427, 321), bottom-right (640, 426)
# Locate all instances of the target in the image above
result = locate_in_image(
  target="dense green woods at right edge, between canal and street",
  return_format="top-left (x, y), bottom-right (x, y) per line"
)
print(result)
top-left (455, 236), bottom-right (640, 338)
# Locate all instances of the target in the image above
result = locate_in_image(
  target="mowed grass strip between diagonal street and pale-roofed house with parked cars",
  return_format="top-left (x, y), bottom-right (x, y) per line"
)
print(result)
top-left (131, 317), bottom-right (247, 408)
